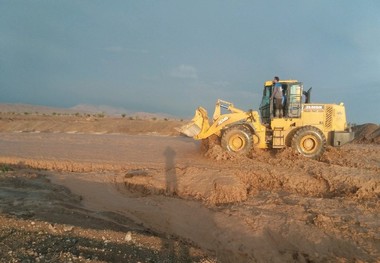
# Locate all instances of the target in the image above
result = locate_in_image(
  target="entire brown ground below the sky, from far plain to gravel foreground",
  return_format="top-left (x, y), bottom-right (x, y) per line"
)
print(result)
top-left (0, 105), bottom-right (380, 262)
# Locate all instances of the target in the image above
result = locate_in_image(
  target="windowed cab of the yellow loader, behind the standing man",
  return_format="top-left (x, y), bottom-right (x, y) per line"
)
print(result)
top-left (260, 80), bottom-right (303, 123)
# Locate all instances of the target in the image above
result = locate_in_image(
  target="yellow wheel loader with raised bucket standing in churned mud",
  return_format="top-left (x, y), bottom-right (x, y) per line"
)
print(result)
top-left (179, 80), bottom-right (354, 159)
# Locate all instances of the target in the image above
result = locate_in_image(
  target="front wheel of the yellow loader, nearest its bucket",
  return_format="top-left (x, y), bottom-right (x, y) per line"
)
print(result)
top-left (221, 125), bottom-right (253, 155)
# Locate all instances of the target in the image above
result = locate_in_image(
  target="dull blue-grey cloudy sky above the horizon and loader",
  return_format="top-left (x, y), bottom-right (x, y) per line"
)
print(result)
top-left (0, 0), bottom-right (380, 123)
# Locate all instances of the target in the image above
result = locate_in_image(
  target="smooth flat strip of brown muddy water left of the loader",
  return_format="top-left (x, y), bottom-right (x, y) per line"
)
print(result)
top-left (0, 133), bottom-right (200, 164)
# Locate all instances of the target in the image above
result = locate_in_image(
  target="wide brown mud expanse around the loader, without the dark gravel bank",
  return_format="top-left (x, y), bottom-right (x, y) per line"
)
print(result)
top-left (0, 133), bottom-right (380, 262)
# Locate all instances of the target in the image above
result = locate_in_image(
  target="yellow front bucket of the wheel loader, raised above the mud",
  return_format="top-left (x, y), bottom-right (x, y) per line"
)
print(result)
top-left (177, 107), bottom-right (210, 138)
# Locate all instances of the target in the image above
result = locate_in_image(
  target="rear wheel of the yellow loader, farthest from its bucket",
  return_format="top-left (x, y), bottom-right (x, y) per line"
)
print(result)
top-left (292, 126), bottom-right (326, 160)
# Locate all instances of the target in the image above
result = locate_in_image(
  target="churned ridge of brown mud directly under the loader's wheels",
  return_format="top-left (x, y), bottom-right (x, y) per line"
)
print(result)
top-left (205, 145), bottom-right (380, 201)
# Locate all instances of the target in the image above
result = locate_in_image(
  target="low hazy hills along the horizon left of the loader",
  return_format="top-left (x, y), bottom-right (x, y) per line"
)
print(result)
top-left (0, 103), bottom-right (177, 119)
